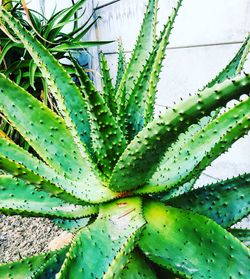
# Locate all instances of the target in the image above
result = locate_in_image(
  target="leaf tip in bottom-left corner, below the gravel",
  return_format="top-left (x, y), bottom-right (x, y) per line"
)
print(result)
top-left (0, 247), bottom-right (69, 279)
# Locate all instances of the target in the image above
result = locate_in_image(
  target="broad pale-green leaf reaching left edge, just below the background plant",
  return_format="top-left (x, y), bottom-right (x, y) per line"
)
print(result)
top-left (0, 75), bottom-right (116, 203)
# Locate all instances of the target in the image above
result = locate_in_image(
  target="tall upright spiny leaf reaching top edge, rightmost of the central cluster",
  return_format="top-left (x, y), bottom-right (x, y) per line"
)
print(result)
top-left (126, 1), bottom-right (182, 140)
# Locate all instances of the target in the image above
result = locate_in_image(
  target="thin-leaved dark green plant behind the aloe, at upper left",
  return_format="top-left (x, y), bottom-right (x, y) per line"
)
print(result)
top-left (0, 0), bottom-right (108, 149)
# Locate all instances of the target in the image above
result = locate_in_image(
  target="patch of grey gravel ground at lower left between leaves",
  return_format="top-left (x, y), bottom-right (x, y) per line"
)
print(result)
top-left (0, 215), bottom-right (63, 263)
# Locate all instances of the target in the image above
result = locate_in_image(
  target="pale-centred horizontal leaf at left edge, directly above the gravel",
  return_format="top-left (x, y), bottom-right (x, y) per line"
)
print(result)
top-left (0, 175), bottom-right (98, 219)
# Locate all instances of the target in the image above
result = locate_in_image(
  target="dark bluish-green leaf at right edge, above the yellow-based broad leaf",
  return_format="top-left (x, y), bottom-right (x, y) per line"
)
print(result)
top-left (167, 174), bottom-right (250, 228)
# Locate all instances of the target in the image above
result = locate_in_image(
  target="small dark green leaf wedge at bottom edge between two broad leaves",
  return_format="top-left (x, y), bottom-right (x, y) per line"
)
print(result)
top-left (119, 250), bottom-right (157, 279)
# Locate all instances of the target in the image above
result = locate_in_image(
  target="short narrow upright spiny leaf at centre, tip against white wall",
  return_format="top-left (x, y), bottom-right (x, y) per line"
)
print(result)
top-left (100, 53), bottom-right (117, 116)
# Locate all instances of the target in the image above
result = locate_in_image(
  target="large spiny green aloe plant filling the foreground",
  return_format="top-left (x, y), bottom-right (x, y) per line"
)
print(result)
top-left (0, 0), bottom-right (250, 279)
